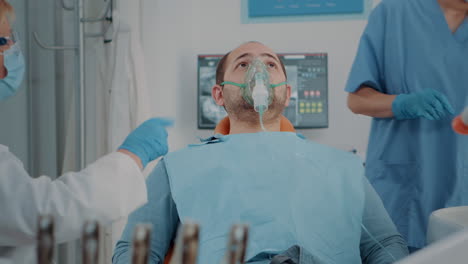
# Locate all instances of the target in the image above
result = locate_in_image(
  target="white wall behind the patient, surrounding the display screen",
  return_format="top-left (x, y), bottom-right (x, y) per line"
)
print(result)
top-left (136, 0), bottom-right (376, 157)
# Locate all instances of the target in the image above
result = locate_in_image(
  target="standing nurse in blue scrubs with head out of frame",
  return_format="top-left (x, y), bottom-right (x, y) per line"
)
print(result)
top-left (346, 0), bottom-right (468, 250)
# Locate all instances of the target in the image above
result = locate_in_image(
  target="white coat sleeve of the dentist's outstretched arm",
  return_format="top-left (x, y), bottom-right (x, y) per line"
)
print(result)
top-left (0, 146), bottom-right (147, 246)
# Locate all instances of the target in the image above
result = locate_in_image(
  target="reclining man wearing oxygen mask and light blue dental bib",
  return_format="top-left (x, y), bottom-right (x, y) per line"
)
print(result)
top-left (113, 42), bottom-right (408, 264)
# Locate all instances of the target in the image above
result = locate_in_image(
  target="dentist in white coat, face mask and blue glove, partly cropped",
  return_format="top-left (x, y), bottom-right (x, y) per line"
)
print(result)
top-left (0, 0), bottom-right (171, 263)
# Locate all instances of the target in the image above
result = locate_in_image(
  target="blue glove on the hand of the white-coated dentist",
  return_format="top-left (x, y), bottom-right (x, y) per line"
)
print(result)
top-left (119, 118), bottom-right (173, 168)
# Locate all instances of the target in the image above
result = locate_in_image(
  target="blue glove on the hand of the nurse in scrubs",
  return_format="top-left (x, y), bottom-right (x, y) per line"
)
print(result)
top-left (392, 89), bottom-right (455, 120)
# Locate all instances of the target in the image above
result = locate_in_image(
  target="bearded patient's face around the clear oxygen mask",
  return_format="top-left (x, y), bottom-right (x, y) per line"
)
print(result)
top-left (223, 42), bottom-right (289, 122)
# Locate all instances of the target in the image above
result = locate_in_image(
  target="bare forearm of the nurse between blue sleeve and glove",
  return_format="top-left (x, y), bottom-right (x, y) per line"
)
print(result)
top-left (348, 86), bottom-right (396, 118)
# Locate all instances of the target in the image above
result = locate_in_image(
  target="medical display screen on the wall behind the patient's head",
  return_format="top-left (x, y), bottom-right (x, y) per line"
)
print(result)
top-left (198, 53), bottom-right (328, 129)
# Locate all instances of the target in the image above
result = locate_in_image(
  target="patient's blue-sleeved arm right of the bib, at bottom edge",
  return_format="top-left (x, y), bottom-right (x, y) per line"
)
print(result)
top-left (360, 179), bottom-right (408, 264)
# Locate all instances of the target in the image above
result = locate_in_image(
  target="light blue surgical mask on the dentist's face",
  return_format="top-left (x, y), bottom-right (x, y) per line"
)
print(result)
top-left (0, 42), bottom-right (25, 101)
